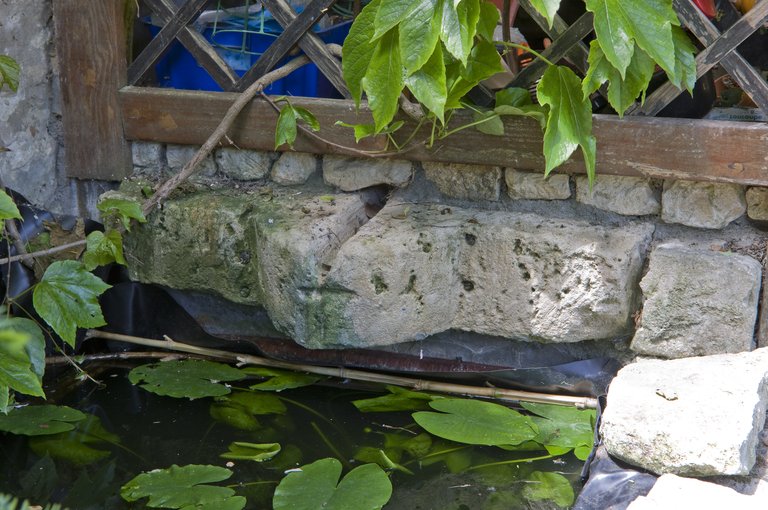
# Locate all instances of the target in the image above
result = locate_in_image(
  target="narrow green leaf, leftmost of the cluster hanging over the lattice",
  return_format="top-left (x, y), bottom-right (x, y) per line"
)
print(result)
top-left (341, 0), bottom-right (382, 108)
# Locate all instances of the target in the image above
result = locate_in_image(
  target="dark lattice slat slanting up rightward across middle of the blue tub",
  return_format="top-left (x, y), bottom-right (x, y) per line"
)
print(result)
top-left (234, 0), bottom-right (336, 91)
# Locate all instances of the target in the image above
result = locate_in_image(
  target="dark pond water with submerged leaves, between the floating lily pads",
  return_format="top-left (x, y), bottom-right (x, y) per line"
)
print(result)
top-left (0, 360), bottom-right (583, 510)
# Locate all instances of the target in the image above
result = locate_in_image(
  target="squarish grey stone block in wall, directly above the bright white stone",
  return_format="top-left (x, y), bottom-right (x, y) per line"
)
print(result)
top-left (632, 243), bottom-right (762, 358)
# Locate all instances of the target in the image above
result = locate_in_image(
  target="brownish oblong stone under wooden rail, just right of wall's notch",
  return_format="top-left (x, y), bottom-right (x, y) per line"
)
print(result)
top-left (422, 162), bottom-right (501, 201)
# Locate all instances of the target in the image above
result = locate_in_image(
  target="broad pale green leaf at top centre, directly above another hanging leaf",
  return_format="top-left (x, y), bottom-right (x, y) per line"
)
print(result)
top-left (400, 0), bottom-right (442, 76)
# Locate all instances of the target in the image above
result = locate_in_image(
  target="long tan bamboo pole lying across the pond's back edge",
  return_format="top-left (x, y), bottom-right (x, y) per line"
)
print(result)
top-left (86, 329), bottom-right (597, 409)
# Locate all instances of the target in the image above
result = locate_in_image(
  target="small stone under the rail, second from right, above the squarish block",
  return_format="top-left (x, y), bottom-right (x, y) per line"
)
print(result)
top-left (661, 181), bottom-right (747, 228)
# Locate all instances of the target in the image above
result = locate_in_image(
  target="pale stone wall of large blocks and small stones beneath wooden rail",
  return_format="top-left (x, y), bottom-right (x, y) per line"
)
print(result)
top-left (122, 143), bottom-right (766, 358)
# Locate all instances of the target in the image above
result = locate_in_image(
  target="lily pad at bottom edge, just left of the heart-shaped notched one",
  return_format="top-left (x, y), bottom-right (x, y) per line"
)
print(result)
top-left (120, 464), bottom-right (246, 510)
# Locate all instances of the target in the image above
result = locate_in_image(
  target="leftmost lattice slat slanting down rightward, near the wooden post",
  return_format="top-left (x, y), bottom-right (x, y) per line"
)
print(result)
top-left (144, 0), bottom-right (238, 90)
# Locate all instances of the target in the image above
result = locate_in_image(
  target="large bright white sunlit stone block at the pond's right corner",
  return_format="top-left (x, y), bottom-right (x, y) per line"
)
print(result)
top-left (601, 348), bottom-right (768, 476)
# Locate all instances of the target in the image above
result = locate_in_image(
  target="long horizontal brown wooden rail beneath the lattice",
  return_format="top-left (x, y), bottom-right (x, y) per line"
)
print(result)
top-left (120, 87), bottom-right (768, 186)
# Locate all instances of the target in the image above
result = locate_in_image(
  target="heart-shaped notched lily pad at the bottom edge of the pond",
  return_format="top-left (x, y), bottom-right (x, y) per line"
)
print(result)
top-left (272, 458), bottom-right (392, 510)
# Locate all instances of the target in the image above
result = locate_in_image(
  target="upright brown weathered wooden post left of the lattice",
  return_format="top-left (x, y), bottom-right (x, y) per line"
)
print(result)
top-left (52, 0), bottom-right (133, 180)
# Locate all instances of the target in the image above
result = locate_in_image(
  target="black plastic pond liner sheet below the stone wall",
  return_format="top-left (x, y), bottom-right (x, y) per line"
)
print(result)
top-left (0, 190), bottom-right (656, 510)
